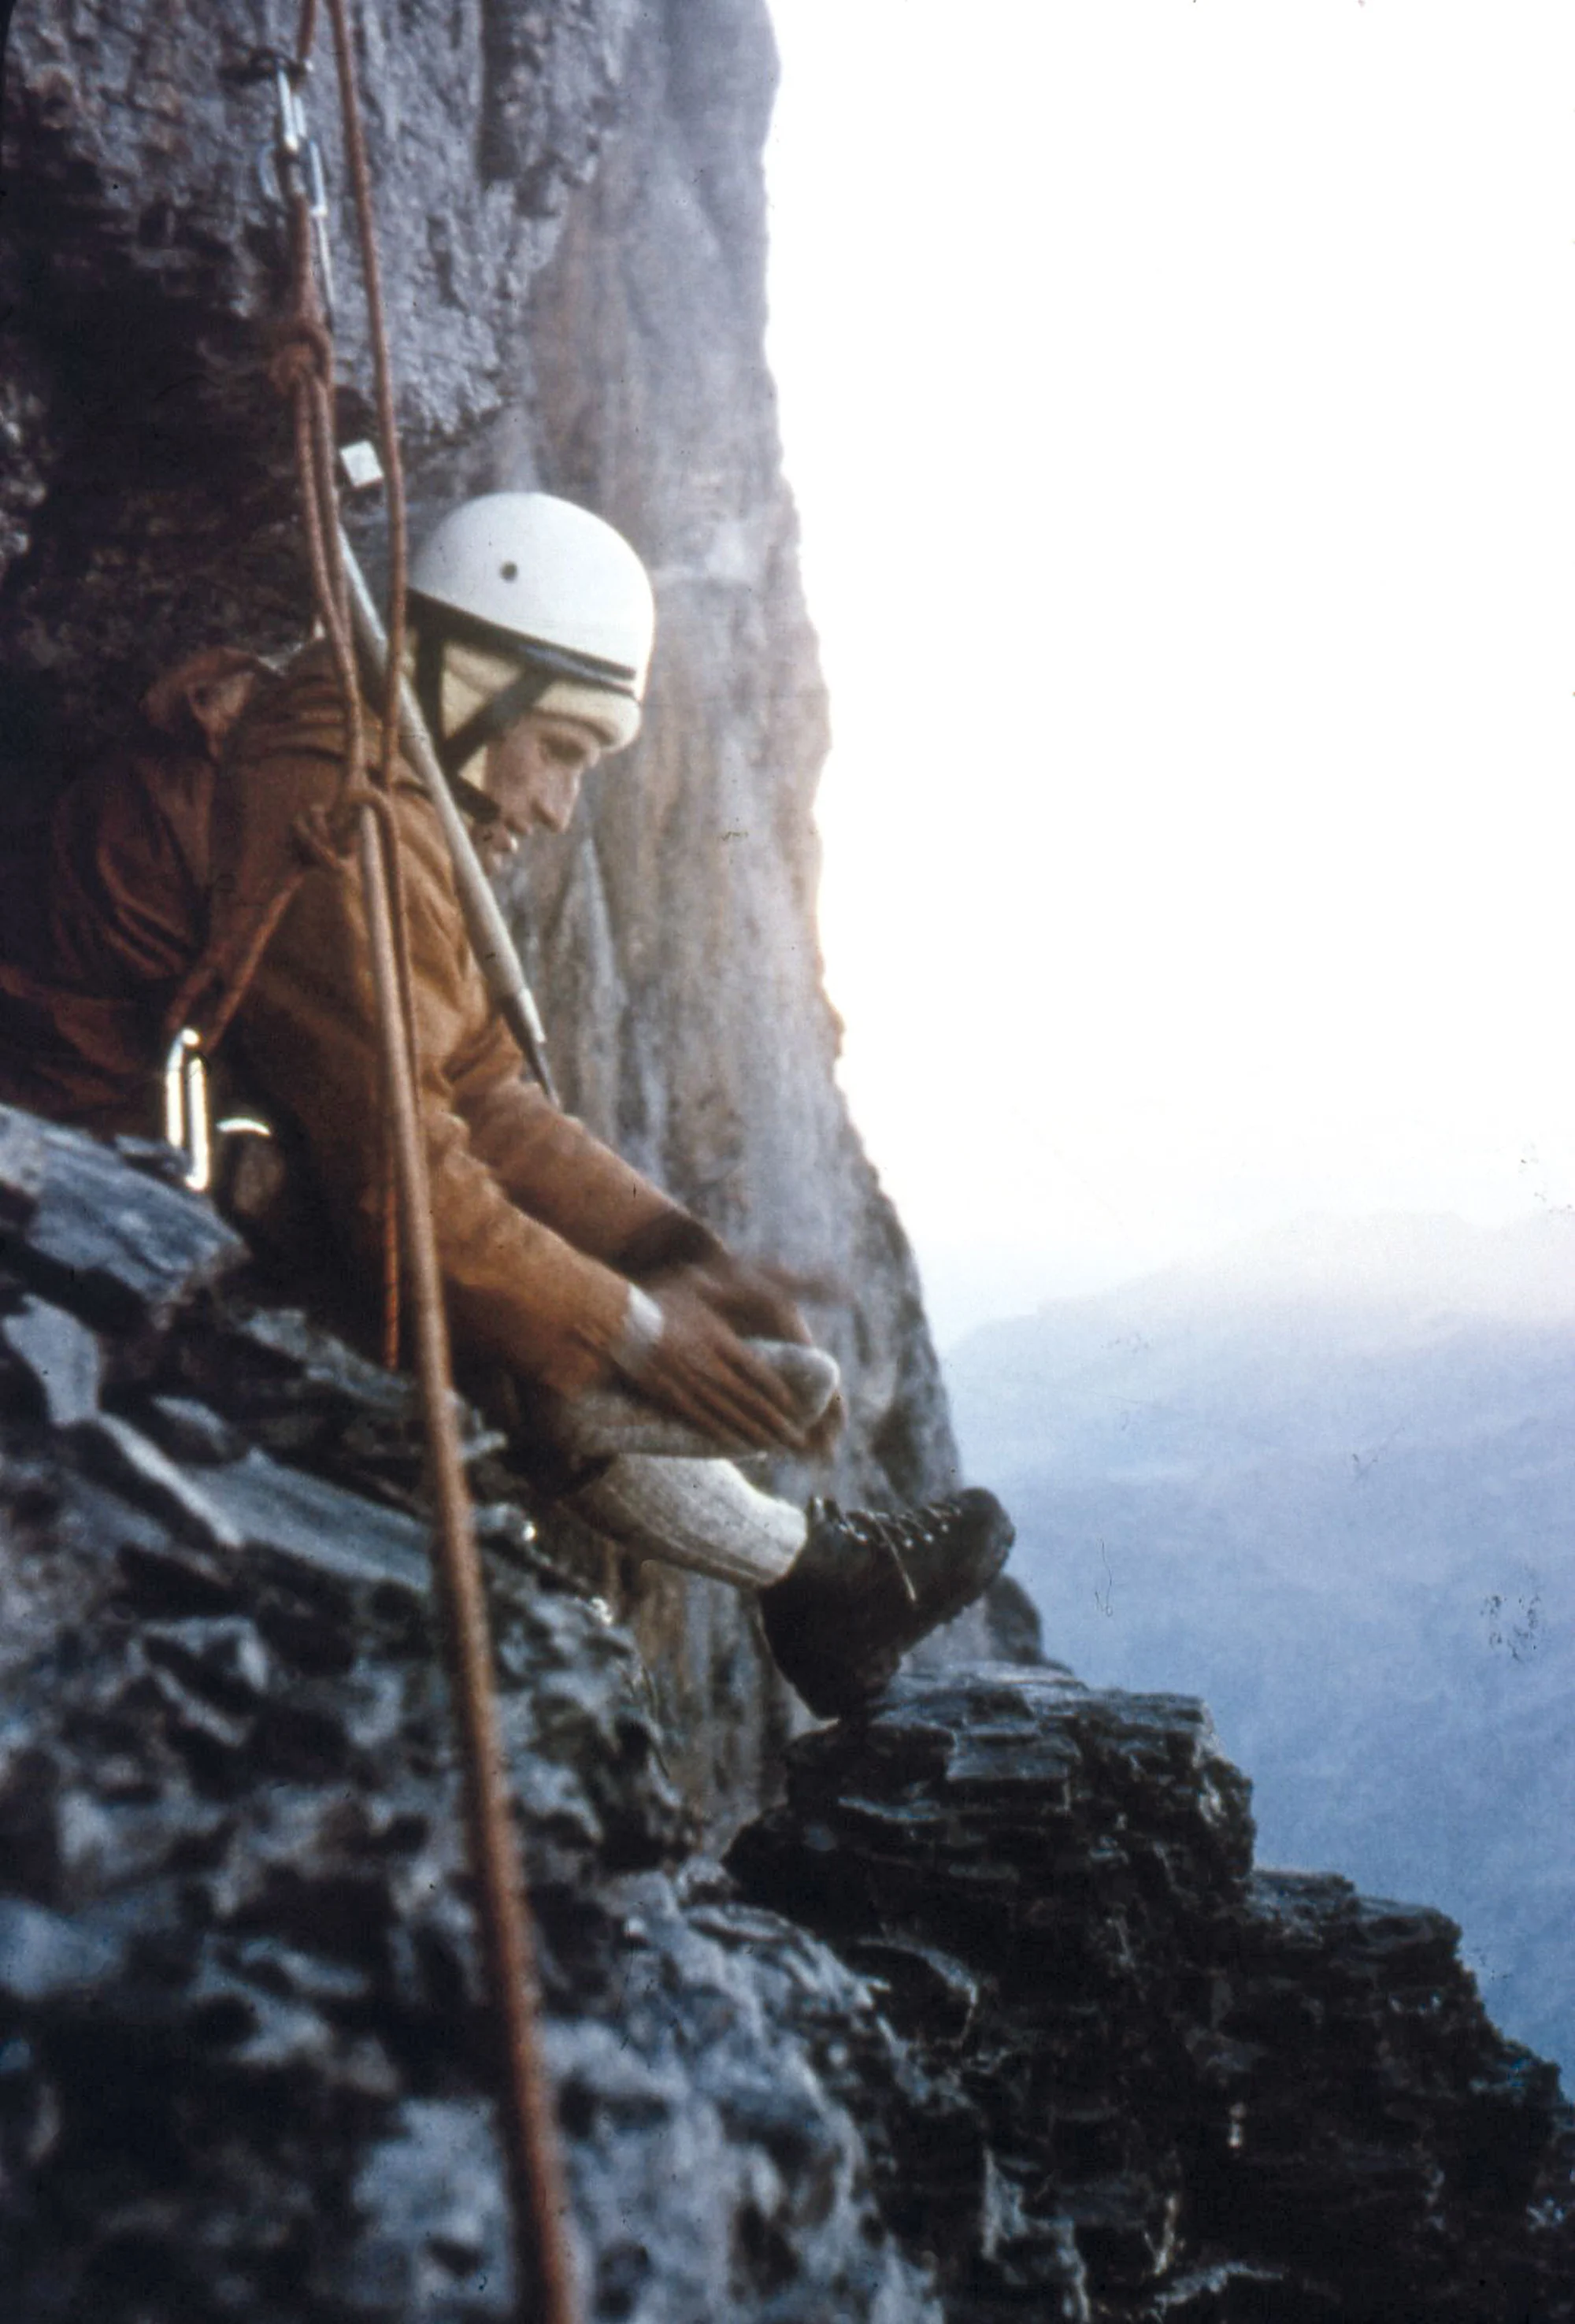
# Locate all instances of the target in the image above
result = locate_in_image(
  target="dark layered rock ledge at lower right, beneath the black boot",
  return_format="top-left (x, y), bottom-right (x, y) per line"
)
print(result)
top-left (729, 1669), bottom-right (1575, 2324)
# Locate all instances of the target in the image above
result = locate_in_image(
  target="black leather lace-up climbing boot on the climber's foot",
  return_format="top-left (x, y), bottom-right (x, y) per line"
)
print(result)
top-left (760, 1490), bottom-right (1013, 1720)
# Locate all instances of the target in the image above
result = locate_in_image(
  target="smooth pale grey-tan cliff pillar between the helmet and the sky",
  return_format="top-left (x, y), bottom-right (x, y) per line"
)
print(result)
top-left (506, 0), bottom-right (975, 1803)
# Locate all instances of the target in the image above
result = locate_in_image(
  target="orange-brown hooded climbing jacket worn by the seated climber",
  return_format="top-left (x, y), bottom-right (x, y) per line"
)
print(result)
top-left (0, 646), bottom-right (706, 1395)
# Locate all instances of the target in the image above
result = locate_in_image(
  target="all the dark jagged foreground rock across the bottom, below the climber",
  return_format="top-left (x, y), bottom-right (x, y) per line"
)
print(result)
top-left (0, 1111), bottom-right (1575, 2324)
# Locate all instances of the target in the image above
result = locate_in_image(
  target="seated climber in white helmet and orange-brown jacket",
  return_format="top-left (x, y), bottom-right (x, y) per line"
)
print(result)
top-left (0, 493), bottom-right (1010, 1715)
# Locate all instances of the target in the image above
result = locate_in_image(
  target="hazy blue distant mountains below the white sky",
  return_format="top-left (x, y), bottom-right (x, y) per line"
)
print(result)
top-left (946, 1210), bottom-right (1575, 2066)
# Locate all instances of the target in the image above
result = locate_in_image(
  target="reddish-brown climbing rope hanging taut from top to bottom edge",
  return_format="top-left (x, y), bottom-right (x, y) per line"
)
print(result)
top-left (249, 0), bottom-right (580, 2324)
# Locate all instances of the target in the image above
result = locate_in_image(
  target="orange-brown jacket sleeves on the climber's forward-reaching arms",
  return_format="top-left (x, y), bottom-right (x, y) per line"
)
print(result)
top-left (237, 767), bottom-right (685, 1395)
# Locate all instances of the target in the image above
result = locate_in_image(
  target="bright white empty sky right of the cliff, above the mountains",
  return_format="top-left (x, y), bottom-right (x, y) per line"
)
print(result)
top-left (769, 0), bottom-right (1575, 1344)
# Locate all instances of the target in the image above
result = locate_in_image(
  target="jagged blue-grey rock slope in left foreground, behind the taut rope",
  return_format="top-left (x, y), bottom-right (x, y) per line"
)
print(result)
top-left (0, 1122), bottom-right (939, 2324)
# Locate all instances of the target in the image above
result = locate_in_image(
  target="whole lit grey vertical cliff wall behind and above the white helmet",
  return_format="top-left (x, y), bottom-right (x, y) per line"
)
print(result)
top-left (0, 0), bottom-right (954, 1806)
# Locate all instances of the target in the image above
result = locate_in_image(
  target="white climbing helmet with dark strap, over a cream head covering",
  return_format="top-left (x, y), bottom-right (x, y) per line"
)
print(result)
top-left (409, 493), bottom-right (655, 774)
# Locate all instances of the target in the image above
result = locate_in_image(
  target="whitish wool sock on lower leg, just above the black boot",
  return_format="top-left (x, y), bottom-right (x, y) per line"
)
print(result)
top-left (565, 1452), bottom-right (809, 1589)
